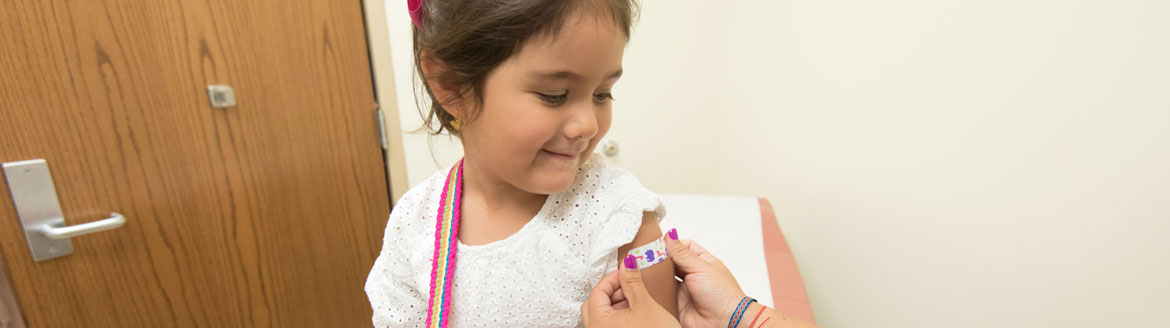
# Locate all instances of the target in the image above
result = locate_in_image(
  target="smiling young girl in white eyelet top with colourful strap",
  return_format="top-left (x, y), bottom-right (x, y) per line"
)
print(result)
top-left (365, 0), bottom-right (677, 327)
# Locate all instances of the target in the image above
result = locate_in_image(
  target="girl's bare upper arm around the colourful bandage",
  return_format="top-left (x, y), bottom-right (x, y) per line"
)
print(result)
top-left (617, 212), bottom-right (679, 317)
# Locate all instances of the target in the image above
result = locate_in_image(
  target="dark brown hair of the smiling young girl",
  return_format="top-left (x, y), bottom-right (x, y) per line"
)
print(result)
top-left (412, 0), bottom-right (638, 135)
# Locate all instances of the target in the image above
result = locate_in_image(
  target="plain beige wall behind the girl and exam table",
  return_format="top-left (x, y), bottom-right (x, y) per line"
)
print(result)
top-left (391, 0), bottom-right (1170, 327)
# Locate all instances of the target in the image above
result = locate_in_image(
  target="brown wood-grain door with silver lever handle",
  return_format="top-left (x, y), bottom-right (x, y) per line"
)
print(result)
top-left (0, 0), bottom-right (390, 327)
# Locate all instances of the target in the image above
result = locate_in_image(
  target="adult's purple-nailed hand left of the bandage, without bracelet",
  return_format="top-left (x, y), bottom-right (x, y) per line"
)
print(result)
top-left (581, 255), bottom-right (681, 328)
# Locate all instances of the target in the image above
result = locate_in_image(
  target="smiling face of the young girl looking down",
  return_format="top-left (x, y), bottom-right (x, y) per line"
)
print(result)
top-left (461, 11), bottom-right (626, 194)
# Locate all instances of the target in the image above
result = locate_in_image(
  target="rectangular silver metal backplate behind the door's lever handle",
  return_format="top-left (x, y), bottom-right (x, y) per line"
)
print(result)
top-left (4, 159), bottom-right (73, 261)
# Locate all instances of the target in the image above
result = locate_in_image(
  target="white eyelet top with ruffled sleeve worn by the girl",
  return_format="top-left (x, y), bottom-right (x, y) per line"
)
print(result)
top-left (365, 155), bottom-right (666, 327)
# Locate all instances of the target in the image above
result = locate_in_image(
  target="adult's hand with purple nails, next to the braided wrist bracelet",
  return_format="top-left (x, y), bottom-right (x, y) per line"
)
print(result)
top-left (666, 228), bottom-right (744, 327)
